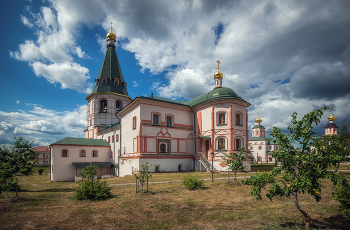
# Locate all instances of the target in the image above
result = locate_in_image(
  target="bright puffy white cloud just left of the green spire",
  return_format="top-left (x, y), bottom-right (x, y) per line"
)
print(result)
top-left (32, 62), bottom-right (92, 93)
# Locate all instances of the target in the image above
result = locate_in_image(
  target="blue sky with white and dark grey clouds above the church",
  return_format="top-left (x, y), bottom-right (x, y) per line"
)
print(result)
top-left (0, 0), bottom-right (350, 145)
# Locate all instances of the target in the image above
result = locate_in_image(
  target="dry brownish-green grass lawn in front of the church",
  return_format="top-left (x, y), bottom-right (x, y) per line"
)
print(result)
top-left (0, 172), bottom-right (350, 229)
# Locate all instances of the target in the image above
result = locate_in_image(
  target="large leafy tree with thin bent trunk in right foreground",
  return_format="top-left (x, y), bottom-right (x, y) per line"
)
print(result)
top-left (243, 107), bottom-right (345, 229)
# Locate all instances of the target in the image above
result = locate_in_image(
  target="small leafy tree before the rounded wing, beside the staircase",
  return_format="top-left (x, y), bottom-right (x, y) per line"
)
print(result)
top-left (223, 147), bottom-right (250, 181)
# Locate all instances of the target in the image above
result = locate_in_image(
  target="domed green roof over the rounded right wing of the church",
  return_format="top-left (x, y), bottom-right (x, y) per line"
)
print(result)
top-left (186, 87), bottom-right (249, 107)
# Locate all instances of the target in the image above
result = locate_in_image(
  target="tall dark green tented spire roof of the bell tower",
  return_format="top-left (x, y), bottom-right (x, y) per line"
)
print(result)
top-left (92, 45), bottom-right (128, 96)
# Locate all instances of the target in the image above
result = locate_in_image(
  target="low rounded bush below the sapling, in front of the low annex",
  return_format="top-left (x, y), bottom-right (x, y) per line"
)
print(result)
top-left (74, 180), bottom-right (112, 200)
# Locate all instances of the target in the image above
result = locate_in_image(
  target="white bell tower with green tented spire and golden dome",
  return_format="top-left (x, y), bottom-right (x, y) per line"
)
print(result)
top-left (84, 23), bottom-right (132, 139)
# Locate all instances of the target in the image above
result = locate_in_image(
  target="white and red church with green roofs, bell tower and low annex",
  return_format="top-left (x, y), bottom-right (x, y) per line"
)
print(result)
top-left (50, 28), bottom-right (252, 181)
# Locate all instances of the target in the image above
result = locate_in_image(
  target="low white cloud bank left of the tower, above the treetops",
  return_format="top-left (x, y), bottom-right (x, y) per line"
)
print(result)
top-left (0, 105), bottom-right (87, 145)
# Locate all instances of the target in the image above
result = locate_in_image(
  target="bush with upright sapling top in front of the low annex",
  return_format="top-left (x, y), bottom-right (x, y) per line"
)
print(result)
top-left (74, 164), bottom-right (112, 200)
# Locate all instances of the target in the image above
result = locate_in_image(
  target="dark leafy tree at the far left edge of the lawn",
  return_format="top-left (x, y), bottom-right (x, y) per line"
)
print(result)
top-left (0, 137), bottom-right (36, 196)
